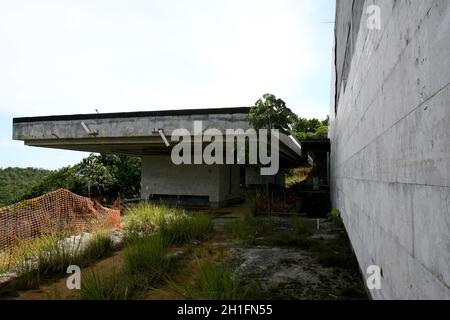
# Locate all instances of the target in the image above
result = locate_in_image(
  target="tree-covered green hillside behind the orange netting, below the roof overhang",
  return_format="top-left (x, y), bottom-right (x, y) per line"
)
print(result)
top-left (0, 154), bottom-right (141, 206)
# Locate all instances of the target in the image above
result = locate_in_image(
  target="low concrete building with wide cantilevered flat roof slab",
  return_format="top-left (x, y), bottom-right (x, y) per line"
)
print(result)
top-left (13, 108), bottom-right (307, 206)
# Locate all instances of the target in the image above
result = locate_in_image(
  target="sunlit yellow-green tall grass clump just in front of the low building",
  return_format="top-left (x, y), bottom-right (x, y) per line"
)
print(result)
top-left (124, 203), bottom-right (213, 244)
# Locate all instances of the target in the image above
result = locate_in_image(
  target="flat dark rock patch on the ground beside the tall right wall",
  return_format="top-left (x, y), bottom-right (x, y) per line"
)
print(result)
top-left (230, 247), bottom-right (364, 300)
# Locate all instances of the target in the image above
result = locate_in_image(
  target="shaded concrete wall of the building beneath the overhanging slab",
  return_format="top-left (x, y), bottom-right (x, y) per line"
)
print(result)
top-left (141, 155), bottom-right (240, 207)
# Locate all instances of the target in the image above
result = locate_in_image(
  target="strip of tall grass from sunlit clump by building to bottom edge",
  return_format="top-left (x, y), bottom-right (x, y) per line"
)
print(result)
top-left (77, 203), bottom-right (213, 300)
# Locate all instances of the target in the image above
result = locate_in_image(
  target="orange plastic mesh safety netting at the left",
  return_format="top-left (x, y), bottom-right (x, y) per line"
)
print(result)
top-left (0, 189), bottom-right (121, 250)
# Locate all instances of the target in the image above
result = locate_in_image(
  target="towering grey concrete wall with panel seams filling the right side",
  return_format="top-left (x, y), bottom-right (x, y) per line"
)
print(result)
top-left (330, 0), bottom-right (450, 299)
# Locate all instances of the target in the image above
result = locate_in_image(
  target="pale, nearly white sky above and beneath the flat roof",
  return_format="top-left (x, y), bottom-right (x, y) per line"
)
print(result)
top-left (0, 0), bottom-right (335, 169)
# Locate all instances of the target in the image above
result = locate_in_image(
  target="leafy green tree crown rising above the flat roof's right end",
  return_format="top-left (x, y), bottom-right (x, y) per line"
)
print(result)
top-left (249, 93), bottom-right (295, 134)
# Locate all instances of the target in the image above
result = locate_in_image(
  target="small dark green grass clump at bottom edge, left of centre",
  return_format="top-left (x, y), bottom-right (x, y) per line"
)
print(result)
top-left (80, 268), bottom-right (135, 300)
